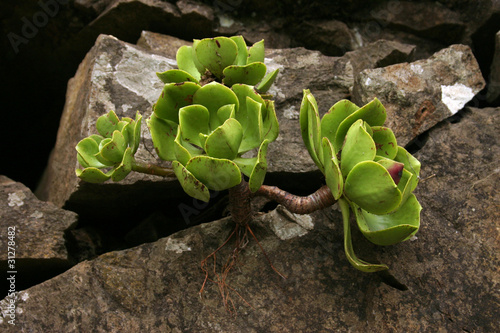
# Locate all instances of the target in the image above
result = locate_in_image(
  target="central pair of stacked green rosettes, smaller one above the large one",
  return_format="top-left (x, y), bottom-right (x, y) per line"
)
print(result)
top-left (148, 36), bottom-right (279, 201)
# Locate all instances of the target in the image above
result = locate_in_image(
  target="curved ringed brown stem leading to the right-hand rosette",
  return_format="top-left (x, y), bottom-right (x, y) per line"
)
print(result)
top-left (255, 185), bottom-right (335, 214)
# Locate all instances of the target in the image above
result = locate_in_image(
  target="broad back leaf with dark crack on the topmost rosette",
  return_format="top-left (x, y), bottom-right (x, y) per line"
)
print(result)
top-left (195, 37), bottom-right (238, 78)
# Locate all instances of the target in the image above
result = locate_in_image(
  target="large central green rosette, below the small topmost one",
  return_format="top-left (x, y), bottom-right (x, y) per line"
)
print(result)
top-left (148, 82), bottom-right (279, 201)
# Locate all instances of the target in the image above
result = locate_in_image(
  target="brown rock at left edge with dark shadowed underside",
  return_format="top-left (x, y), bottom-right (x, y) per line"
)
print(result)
top-left (0, 176), bottom-right (78, 296)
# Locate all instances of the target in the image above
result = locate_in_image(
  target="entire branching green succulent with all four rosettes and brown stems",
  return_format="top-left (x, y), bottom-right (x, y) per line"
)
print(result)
top-left (76, 36), bottom-right (421, 276)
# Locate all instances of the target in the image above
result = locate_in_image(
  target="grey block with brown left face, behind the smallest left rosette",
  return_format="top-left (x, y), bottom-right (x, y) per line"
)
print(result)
top-left (37, 35), bottom-right (184, 215)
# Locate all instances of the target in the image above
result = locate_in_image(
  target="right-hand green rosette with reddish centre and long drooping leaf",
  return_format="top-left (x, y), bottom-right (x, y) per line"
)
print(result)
top-left (300, 90), bottom-right (421, 271)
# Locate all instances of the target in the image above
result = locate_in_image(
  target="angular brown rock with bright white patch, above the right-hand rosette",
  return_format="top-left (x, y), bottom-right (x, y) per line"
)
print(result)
top-left (353, 45), bottom-right (485, 146)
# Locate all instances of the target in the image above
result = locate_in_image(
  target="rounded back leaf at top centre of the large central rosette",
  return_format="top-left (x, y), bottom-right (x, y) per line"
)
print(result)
top-left (193, 82), bottom-right (239, 131)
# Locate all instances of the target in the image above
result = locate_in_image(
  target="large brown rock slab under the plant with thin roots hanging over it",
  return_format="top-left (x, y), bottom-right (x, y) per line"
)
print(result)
top-left (0, 108), bottom-right (500, 332)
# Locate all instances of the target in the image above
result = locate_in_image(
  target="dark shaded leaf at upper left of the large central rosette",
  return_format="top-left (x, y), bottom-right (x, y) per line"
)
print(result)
top-left (153, 82), bottom-right (200, 124)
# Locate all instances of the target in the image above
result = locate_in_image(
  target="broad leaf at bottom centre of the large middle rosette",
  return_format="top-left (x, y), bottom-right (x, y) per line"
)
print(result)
top-left (186, 155), bottom-right (241, 191)
